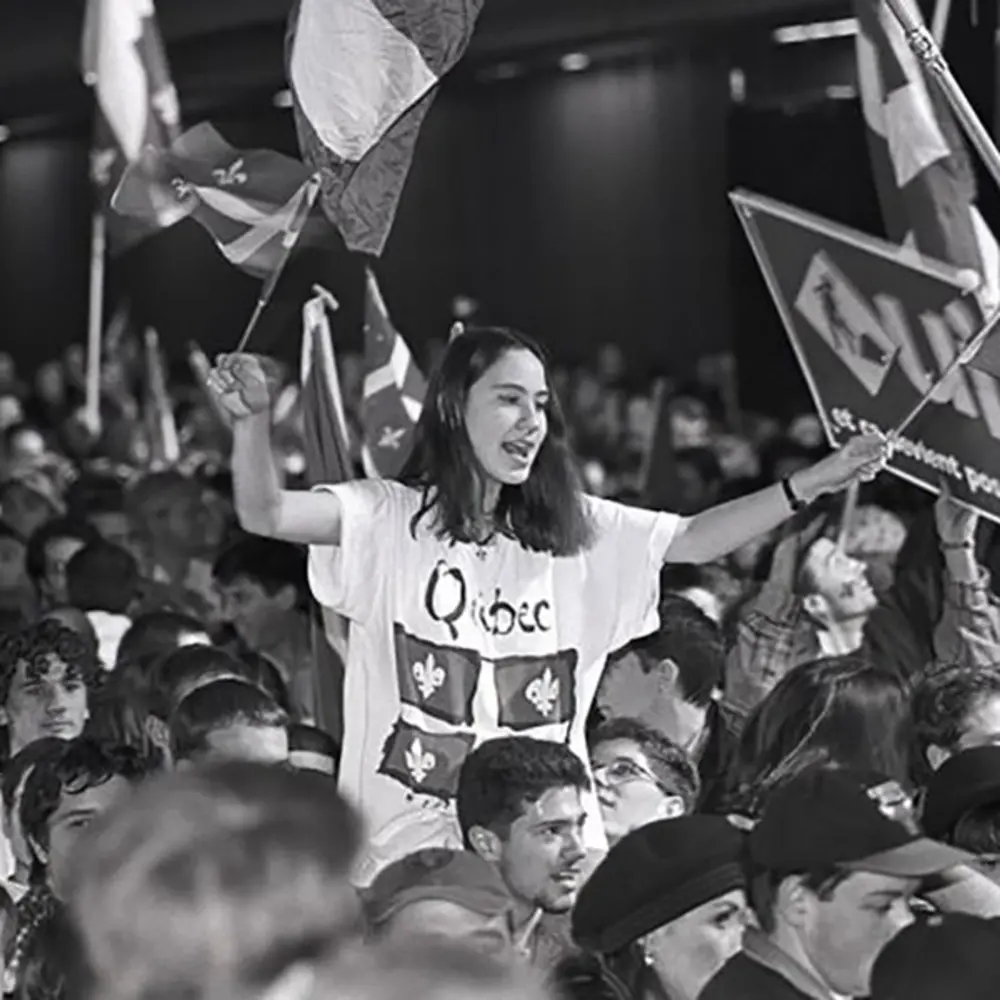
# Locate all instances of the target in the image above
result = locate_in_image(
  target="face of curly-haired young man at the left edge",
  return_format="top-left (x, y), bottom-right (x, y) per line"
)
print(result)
top-left (0, 653), bottom-right (88, 755)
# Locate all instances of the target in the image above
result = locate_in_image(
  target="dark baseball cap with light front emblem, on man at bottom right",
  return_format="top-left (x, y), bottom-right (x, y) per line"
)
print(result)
top-left (750, 767), bottom-right (972, 878)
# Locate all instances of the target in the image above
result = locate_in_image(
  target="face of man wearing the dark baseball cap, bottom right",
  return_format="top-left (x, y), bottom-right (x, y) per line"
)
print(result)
top-left (798, 872), bottom-right (919, 997)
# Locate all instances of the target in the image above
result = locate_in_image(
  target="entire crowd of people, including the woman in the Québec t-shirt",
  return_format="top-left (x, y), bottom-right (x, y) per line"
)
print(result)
top-left (0, 327), bottom-right (1000, 1000)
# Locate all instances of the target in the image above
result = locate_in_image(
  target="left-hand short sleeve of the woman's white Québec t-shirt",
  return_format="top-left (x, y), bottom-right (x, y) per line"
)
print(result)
top-left (309, 479), bottom-right (410, 621)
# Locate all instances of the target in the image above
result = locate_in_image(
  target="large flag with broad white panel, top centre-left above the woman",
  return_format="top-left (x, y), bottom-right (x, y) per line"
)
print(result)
top-left (288, 0), bottom-right (483, 256)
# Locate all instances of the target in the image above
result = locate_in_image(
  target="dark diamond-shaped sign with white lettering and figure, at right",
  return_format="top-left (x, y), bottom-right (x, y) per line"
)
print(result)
top-left (731, 191), bottom-right (1000, 522)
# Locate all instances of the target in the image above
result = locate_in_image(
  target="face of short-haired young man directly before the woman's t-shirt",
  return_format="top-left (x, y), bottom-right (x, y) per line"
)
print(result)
top-left (499, 787), bottom-right (587, 913)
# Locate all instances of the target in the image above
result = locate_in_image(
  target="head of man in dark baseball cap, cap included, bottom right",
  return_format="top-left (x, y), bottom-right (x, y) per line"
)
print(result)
top-left (749, 767), bottom-right (970, 996)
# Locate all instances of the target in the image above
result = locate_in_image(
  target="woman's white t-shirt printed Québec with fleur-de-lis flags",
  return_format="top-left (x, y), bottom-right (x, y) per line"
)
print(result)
top-left (309, 479), bottom-right (679, 881)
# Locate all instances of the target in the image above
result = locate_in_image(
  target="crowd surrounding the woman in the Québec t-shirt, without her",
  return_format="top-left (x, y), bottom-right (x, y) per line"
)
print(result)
top-left (0, 339), bottom-right (1000, 1000)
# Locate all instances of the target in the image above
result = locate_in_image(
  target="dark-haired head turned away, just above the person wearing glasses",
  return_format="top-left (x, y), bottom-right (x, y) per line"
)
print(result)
top-left (597, 595), bottom-right (726, 743)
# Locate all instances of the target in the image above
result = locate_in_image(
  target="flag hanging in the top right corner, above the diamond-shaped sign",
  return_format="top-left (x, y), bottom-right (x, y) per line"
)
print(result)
top-left (854, 0), bottom-right (1000, 310)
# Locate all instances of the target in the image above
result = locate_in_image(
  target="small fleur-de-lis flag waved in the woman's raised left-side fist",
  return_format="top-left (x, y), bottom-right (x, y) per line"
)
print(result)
top-left (111, 122), bottom-right (320, 278)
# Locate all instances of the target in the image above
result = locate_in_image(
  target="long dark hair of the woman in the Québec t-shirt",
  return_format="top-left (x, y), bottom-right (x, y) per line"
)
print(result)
top-left (399, 327), bottom-right (593, 556)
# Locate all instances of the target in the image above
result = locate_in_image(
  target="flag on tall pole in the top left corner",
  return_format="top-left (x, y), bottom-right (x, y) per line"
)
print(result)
top-left (81, 0), bottom-right (180, 252)
